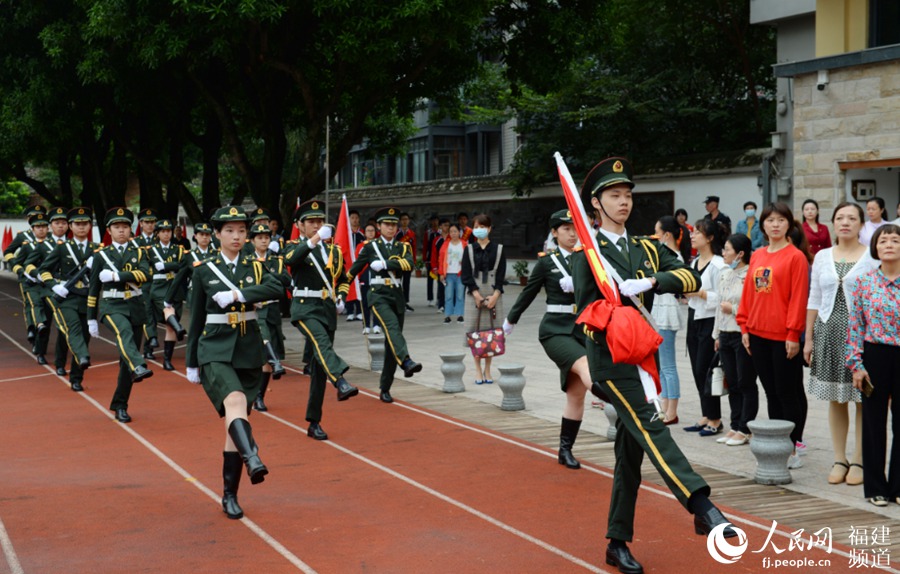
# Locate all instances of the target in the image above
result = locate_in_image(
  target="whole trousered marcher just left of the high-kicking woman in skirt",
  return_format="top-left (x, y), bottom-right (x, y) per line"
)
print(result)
top-left (88, 207), bottom-right (153, 423)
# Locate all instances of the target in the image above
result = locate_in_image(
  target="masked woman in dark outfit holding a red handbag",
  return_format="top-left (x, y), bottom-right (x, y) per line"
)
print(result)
top-left (460, 213), bottom-right (506, 385)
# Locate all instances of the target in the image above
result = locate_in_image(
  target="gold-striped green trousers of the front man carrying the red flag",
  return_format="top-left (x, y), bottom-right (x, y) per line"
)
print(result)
top-left (600, 378), bottom-right (709, 542)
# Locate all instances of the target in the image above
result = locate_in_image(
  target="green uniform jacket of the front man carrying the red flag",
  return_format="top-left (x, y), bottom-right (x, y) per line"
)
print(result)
top-left (572, 232), bottom-right (700, 380)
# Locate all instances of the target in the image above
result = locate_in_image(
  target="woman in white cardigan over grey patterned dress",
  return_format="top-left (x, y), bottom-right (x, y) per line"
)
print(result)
top-left (803, 202), bottom-right (878, 485)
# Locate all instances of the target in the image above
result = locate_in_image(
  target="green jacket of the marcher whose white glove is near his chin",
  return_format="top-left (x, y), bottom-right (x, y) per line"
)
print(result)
top-left (284, 239), bottom-right (350, 332)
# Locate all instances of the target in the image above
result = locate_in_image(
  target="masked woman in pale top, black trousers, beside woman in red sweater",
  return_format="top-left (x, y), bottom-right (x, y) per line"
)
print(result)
top-left (713, 233), bottom-right (759, 446)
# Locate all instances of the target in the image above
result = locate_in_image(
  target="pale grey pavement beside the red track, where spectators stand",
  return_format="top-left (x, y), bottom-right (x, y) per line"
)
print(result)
top-left (312, 277), bottom-right (900, 520)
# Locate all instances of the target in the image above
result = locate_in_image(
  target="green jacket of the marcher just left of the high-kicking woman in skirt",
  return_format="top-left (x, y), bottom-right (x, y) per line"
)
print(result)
top-left (88, 241), bottom-right (150, 323)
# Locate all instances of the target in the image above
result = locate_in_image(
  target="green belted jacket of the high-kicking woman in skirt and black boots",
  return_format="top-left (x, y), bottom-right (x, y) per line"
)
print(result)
top-left (185, 256), bottom-right (282, 369)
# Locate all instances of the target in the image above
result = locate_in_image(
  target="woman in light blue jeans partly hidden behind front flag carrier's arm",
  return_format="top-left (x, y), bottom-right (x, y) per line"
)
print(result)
top-left (651, 215), bottom-right (684, 425)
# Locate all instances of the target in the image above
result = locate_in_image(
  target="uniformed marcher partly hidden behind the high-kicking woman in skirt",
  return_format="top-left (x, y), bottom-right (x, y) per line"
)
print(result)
top-left (250, 224), bottom-right (291, 412)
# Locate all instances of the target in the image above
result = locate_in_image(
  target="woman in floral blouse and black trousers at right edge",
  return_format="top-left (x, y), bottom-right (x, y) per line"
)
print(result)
top-left (846, 223), bottom-right (900, 506)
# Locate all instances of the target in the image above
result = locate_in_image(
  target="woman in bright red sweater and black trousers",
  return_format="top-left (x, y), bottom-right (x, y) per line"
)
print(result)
top-left (736, 202), bottom-right (809, 468)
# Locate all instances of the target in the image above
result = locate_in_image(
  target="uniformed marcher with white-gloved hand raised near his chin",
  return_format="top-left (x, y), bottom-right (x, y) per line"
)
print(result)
top-left (284, 199), bottom-right (359, 440)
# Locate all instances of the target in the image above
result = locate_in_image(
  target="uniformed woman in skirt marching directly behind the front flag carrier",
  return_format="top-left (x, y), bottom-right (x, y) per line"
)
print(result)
top-left (503, 209), bottom-right (591, 469)
